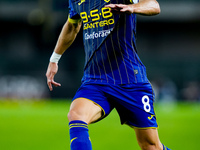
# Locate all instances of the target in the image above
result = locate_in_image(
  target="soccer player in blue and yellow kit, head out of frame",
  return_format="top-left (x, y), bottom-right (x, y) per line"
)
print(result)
top-left (46, 0), bottom-right (171, 150)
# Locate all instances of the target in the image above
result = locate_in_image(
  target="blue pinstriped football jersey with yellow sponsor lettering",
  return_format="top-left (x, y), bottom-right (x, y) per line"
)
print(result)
top-left (69, 0), bottom-right (148, 84)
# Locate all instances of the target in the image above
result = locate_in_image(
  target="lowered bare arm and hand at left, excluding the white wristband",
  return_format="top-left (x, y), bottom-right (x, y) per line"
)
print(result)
top-left (46, 18), bottom-right (82, 91)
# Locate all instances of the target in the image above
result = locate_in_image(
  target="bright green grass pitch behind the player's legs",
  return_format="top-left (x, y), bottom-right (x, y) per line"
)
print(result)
top-left (0, 100), bottom-right (200, 150)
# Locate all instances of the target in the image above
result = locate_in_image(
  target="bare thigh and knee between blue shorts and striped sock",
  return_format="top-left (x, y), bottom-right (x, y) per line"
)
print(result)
top-left (68, 98), bottom-right (102, 124)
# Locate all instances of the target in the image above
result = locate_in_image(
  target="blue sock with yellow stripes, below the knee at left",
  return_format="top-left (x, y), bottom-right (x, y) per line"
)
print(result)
top-left (69, 120), bottom-right (92, 150)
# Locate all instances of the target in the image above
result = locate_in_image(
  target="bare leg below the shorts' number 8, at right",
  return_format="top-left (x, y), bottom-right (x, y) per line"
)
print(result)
top-left (134, 128), bottom-right (162, 149)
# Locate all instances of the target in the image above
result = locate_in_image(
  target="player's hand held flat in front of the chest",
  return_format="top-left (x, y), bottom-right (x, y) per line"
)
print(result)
top-left (105, 4), bottom-right (134, 14)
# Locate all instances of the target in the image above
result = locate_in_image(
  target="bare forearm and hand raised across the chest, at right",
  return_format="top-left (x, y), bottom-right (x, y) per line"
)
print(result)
top-left (105, 0), bottom-right (160, 16)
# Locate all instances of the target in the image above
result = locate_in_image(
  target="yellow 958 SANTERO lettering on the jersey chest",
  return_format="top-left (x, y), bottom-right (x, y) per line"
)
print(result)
top-left (80, 7), bottom-right (115, 30)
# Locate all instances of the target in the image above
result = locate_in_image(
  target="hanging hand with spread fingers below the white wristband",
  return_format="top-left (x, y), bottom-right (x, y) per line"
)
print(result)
top-left (46, 62), bottom-right (61, 91)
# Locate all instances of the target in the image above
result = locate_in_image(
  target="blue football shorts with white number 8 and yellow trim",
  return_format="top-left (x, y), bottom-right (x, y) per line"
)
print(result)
top-left (73, 82), bottom-right (158, 128)
